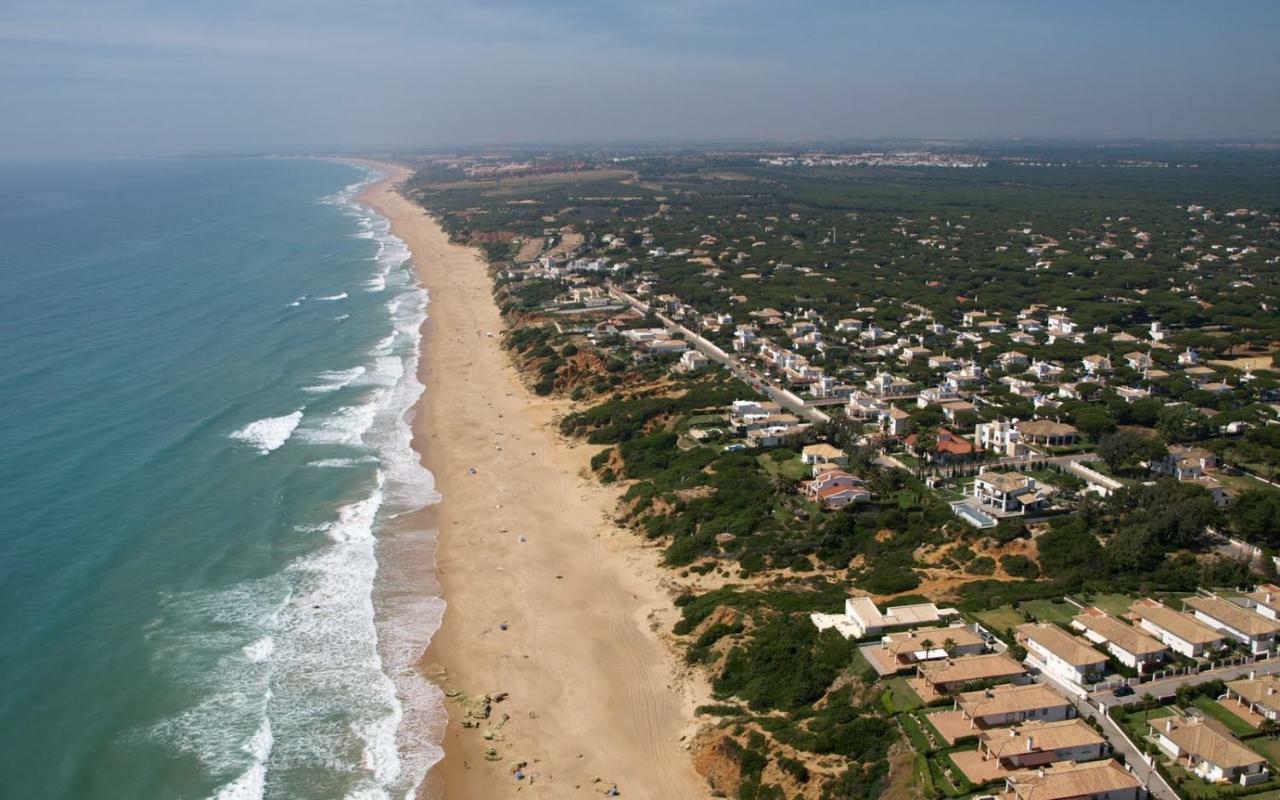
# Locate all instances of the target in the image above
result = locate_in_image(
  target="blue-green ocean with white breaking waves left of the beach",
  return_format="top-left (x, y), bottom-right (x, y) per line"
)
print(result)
top-left (0, 159), bottom-right (444, 800)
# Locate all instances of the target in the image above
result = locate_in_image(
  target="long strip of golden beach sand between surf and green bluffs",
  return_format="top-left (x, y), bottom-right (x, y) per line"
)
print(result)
top-left (364, 165), bottom-right (709, 800)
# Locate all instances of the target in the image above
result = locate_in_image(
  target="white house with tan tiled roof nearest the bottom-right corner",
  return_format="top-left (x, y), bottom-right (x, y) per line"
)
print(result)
top-left (1151, 714), bottom-right (1271, 786)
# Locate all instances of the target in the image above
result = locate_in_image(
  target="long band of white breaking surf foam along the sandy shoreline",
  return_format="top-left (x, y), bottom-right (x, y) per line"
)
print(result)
top-left (165, 163), bottom-right (445, 800)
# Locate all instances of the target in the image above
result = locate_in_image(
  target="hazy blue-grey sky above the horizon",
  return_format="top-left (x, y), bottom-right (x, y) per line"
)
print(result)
top-left (0, 0), bottom-right (1280, 157)
